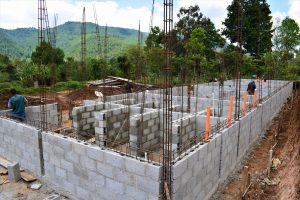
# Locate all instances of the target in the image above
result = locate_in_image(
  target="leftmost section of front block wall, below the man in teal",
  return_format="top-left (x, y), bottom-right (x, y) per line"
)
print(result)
top-left (0, 118), bottom-right (42, 175)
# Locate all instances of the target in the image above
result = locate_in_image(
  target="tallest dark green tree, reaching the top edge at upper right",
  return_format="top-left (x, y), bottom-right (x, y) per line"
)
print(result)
top-left (222, 0), bottom-right (274, 59)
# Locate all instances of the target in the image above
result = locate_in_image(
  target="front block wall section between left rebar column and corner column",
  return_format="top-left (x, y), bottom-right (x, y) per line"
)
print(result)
top-left (43, 133), bottom-right (162, 200)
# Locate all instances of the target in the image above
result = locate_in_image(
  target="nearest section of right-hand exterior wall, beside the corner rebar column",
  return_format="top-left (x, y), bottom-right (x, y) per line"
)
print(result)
top-left (172, 135), bottom-right (221, 200)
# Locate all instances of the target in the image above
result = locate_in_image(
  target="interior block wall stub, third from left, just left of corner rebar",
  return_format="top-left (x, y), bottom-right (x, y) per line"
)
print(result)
top-left (129, 111), bottom-right (161, 156)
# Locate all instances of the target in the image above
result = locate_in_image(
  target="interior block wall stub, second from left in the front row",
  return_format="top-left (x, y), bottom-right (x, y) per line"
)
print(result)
top-left (95, 107), bottom-right (129, 146)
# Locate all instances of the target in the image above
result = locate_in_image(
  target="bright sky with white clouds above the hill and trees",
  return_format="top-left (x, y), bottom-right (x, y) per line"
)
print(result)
top-left (0, 0), bottom-right (300, 32)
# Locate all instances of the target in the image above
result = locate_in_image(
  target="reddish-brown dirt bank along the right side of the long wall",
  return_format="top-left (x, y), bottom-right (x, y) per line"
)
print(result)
top-left (213, 85), bottom-right (300, 200)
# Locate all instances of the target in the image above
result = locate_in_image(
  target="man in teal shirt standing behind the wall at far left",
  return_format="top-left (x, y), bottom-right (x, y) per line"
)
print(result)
top-left (8, 89), bottom-right (28, 121)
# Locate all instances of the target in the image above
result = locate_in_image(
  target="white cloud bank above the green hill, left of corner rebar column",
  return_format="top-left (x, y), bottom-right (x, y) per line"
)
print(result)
top-left (0, 0), bottom-right (163, 31)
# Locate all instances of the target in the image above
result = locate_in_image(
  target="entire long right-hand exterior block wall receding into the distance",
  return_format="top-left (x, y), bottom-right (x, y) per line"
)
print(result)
top-left (172, 83), bottom-right (292, 200)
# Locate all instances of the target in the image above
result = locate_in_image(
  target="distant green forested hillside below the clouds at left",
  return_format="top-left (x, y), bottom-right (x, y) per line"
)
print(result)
top-left (0, 22), bottom-right (146, 59)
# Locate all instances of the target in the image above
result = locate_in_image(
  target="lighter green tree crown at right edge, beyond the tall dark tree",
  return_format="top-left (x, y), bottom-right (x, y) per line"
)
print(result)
top-left (278, 17), bottom-right (300, 53)
